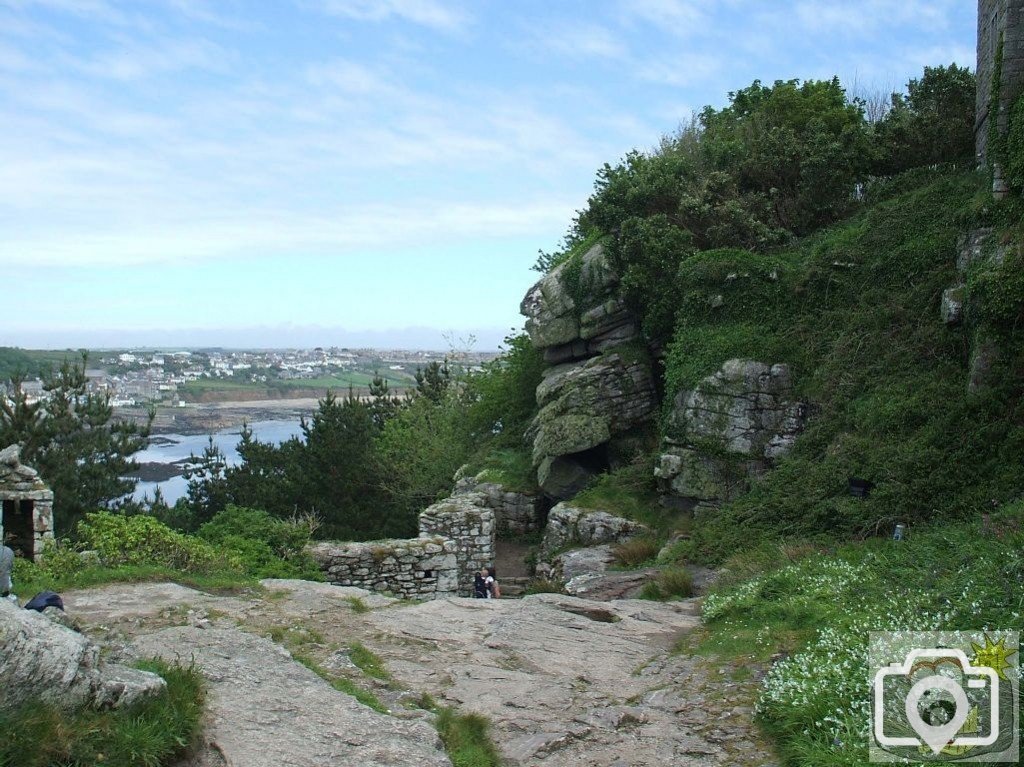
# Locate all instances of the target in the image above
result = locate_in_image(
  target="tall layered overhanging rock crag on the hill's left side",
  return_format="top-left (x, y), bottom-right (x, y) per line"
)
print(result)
top-left (520, 245), bottom-right (657, 500)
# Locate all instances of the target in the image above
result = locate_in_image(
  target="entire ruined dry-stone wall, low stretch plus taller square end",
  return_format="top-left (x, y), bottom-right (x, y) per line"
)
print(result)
top-left (307, 493), bottom-right (496, 599)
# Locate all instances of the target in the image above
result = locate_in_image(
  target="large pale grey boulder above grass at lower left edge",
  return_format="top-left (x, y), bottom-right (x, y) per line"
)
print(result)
top-left (0, 599), bottom-right (166, 711)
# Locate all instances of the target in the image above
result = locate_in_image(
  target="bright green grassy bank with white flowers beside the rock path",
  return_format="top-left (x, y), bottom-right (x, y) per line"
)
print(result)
top-left (702, 502), bottom-right (1024, 767)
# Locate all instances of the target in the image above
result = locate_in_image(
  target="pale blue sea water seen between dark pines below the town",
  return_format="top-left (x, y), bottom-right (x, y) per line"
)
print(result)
top-left (132, 419), bottom-right (302, 506)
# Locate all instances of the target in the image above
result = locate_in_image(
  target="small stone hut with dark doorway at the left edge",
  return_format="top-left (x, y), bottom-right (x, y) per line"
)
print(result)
top-left (0, 444), bottom-right (53, 560)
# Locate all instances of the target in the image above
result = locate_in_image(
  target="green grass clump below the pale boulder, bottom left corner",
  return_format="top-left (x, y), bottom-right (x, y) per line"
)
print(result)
top-left (0, 661), bottom-right (205, 767)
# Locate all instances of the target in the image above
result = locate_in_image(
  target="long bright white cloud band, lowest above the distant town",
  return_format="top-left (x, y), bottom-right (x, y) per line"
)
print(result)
top-left (0, 198), bottom-right (577, 267)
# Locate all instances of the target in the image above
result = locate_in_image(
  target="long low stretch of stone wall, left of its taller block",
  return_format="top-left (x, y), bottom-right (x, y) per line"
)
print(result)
top-left (307, 536), bottom-right (458, 599)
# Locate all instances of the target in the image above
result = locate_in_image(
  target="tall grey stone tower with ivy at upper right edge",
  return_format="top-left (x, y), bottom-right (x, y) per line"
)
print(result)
top-left (974, 0), bottom-right (1024, 194)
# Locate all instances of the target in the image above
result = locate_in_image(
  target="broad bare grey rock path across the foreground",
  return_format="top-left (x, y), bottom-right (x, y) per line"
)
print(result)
top-left (66, 581), bottom-right (774, 767)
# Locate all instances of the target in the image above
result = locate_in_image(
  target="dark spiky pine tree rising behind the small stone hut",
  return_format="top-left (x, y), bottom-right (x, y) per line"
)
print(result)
top-left (0, 353), bottom-right (153, 534)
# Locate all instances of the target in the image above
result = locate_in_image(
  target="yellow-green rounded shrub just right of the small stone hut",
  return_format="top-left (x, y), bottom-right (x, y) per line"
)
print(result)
top-left (78, 511), bottom-right (237, 572)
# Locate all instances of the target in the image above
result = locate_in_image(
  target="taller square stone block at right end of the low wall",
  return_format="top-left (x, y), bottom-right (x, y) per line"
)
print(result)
top-left (420, 493), bottom-right (495, 597)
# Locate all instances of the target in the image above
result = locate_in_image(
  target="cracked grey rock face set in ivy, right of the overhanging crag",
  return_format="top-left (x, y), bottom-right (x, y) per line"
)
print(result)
top-left (654, 359), bottom-right (807, 510)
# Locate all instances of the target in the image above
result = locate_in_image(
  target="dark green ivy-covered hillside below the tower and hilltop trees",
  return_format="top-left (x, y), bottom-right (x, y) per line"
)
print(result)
top-left (651, 171), bottom-right (1024, 562)
